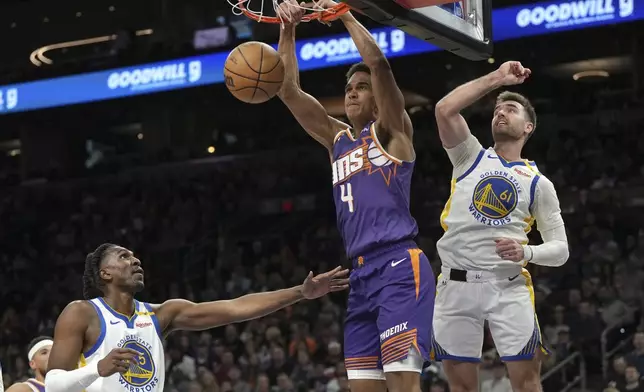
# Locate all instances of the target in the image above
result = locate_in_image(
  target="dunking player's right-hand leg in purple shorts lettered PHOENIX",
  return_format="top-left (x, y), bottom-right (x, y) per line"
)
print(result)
top-left (373, 249), bottom-right (436, 392)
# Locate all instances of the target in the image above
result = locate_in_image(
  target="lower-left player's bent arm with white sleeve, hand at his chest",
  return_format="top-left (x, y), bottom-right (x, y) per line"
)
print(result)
top-left (45, 301), bottom-right (139, 392)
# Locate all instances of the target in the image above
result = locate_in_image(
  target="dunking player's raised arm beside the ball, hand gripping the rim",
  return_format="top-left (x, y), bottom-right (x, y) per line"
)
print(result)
top-left (277, 1), bottom-right (350, 150)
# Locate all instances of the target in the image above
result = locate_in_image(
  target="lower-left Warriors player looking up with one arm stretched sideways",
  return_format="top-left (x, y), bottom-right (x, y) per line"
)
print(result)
top-left (45, 244), bottom-right (349, 392)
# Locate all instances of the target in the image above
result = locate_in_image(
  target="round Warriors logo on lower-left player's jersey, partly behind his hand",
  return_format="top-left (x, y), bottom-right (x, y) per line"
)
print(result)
top-left (118, 335), bottom-right (159, 391)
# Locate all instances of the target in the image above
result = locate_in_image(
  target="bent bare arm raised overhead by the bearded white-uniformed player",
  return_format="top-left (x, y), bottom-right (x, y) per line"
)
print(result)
top-left (435, 61), bottom-right (531, 149)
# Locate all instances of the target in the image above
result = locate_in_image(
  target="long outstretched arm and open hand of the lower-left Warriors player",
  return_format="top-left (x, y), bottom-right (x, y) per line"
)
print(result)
top-left (155, 267), bottom-right (349, 334)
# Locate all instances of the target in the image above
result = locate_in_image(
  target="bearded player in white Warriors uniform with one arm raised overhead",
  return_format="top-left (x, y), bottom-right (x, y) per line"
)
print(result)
top-left (432, 61), bottom-right (568, 392)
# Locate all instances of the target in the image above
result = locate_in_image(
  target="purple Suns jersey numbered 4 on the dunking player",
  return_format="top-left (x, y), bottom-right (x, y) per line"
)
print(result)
top-left (332, 123), bottom-right (418, 258)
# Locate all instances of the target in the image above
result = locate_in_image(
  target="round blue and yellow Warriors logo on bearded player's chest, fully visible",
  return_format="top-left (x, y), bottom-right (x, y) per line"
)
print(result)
top-left (469, 170), bottom-right (521, 226)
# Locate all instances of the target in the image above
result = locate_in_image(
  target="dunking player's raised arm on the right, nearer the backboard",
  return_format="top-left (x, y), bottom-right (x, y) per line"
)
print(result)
top-left (340, 12), bottom-right (406, 138)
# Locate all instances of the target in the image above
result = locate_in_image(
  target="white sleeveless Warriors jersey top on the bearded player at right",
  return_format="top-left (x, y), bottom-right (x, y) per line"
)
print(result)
top-left (436, 141), bottom-right (541, 271)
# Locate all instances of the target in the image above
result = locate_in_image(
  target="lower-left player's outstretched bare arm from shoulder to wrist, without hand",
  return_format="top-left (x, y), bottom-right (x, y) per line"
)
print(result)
top-left (157, 286), bottom-right (304, 333)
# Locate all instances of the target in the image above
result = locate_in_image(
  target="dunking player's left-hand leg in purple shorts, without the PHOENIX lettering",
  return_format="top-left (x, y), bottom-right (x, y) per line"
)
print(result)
top-left (344, 278), bottom-right (387, 392)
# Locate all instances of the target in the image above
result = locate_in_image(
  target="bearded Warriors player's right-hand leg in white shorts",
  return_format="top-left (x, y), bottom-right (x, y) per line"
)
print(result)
top-left (488, 270), bottom-right (547, 392)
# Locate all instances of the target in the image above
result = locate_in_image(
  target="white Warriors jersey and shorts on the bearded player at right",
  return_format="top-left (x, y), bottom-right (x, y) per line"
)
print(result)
top-left (432, 135), bottom-right (564, 362)
